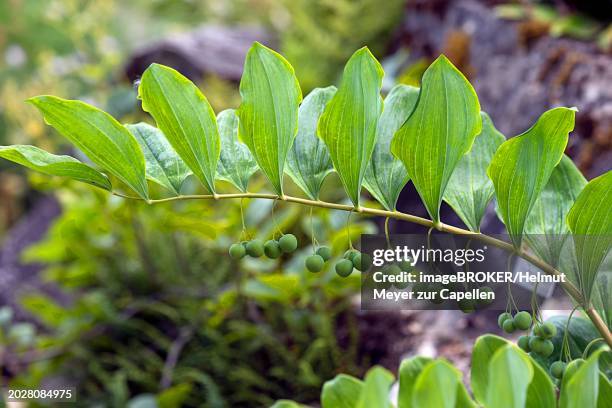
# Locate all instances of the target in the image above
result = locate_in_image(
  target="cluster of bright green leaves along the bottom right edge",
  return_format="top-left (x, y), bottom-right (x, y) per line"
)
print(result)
top-left (273, 335), bottom-right (612, 408)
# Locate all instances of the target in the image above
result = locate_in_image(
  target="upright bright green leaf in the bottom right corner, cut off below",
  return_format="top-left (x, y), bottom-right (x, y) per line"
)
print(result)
top-left (559, 352), bottom-right (600, 408)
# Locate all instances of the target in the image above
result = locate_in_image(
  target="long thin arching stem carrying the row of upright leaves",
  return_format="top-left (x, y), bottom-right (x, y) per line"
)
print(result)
top-left (113, 192), bottom-right (612, 347)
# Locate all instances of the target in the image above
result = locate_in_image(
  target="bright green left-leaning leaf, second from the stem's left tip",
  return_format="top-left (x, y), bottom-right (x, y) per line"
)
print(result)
top-left (28, 95), bottom-right (149, 199)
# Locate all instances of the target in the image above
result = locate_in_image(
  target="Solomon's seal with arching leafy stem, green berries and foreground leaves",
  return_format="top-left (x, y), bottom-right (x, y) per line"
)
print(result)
top-left (0, 39), bottom-right (612, 406)
